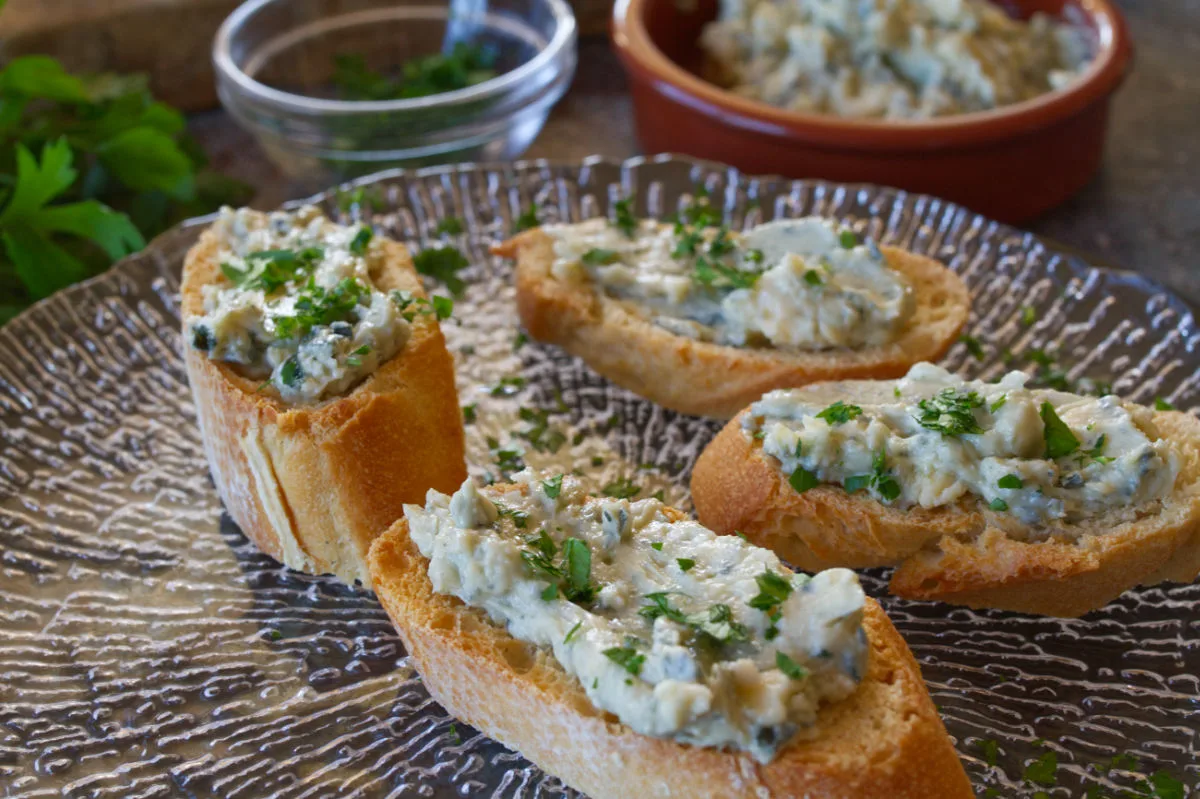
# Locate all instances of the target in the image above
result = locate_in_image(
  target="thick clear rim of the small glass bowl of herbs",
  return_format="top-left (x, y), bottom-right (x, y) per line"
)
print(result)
top-left (212, 0), bottom-right (576, 114)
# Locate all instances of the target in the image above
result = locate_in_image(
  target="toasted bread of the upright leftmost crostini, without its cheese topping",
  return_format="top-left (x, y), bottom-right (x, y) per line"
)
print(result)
top-left (181, 224), bottom-right (467, 588)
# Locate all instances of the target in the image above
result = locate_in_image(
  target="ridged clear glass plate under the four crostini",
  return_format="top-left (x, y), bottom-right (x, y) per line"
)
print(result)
top-left (0, 152), bottom-right (1200, 799)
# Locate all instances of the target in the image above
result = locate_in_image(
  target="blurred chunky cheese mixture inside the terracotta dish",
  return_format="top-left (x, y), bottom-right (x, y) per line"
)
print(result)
top-left (701, 0), bottom-right (1093, 119)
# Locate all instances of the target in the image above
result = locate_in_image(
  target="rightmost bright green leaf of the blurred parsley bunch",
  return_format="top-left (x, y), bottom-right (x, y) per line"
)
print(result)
top-left (96, 126), bottom-right (196, 200)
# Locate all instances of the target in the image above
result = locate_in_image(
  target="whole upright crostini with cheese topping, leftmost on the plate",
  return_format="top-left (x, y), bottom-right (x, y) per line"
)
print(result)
top-left (181, 206), bottom-right (466, 587)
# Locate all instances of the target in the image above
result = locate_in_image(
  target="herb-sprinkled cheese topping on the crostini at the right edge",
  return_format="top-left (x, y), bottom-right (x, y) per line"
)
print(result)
top-left (743, 364), bottom-right (1178, 524)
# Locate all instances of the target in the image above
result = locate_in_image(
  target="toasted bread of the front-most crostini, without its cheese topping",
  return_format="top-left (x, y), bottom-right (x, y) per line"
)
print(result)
top-left (371, 499), bottom-right (973, 799)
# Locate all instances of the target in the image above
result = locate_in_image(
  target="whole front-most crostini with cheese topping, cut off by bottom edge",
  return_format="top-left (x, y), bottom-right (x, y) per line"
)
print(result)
top-left (371, 470), bottom-right (973, 799)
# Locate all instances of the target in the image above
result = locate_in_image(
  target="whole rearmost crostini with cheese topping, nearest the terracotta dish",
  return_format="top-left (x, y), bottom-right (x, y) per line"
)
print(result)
top-left (493, 203), bottom-right (970, 419)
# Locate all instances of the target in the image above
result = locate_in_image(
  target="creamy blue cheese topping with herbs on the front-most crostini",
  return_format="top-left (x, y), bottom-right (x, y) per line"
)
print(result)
top-left (404, 470), bottom-right (868, 762)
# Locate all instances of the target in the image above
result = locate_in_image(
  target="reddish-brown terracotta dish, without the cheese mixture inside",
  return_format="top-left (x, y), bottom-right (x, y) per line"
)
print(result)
top-left (612, 0), bottom-right (1133, 222)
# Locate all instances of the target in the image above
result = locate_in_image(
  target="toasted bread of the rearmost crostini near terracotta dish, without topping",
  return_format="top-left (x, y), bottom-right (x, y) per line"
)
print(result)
top-left (492, 229), bottom-right (971, 419)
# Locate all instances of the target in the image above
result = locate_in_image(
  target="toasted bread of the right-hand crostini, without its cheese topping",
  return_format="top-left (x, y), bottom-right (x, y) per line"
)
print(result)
top-left (691, 400), bottom-right (1200, 617)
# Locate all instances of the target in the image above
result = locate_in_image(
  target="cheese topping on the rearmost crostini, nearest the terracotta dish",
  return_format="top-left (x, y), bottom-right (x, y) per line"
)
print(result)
top-left (544, 217), bottom-right (914, 350)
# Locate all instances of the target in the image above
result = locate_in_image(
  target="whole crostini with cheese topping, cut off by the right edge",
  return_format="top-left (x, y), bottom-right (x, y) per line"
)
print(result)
top-left (691, 364), bottom-right (1200, 617)
